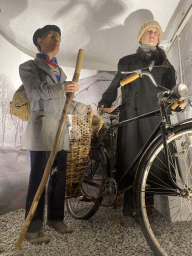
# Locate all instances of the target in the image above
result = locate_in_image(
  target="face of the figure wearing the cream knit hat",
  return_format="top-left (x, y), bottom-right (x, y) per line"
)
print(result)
top-left (140, 27), bottom-right (159, 47)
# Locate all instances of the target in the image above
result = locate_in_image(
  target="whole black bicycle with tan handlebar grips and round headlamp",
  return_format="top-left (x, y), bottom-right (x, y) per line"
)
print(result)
top-left (66, 70), bottom-right (192, 256)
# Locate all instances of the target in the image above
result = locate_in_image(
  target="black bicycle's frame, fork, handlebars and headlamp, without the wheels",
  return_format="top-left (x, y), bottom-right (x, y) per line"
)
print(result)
top-left (95, 70), bottom-right (188, 200)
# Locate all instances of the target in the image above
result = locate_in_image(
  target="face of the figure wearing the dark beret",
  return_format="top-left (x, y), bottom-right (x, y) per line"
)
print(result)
top-left (37, 31), bottom-right (61, 56)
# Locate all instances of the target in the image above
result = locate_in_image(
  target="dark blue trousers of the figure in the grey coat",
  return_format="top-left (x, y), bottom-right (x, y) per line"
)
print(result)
top-left (25, 150), bottom-right (67, 232)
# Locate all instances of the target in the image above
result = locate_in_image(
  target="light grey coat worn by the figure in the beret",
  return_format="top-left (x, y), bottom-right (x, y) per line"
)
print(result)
top-left (19, 58), bottom-right (87, 151)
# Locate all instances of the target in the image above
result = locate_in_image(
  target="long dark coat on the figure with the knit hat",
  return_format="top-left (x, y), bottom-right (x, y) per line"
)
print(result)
top-left (98, 49), bottom-right (176, 185)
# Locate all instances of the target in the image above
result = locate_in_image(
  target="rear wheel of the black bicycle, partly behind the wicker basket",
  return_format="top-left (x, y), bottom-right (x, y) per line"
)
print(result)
top-left (66, 146), bottom-right (107, 219)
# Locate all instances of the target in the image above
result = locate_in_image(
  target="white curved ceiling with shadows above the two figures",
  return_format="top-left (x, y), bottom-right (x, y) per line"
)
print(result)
top-left (0, 0), bottom-right (191, 70)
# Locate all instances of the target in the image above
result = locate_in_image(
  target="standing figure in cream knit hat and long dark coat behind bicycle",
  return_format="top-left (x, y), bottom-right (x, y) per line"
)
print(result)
top-left (98, 20), bottom-right (186, 232)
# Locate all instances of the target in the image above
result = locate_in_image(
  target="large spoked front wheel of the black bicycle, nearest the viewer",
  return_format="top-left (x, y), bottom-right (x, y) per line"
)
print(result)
top-left (134, 120), bottom-right (192, 256)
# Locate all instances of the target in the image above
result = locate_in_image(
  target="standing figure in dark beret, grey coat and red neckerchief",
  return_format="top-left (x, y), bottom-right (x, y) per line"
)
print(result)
top-left (19, 25), bottom-right (92, 243)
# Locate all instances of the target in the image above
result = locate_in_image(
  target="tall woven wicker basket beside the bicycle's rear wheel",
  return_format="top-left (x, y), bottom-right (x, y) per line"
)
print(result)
top-left (66, 114), bottom-right (104, 199)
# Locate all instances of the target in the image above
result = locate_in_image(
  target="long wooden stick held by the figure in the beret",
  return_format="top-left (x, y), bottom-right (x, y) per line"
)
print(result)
top-left (16, 49), bottom-right (84, 255)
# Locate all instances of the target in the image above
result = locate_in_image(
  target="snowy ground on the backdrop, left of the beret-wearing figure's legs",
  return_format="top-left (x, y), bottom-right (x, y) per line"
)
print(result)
top-left (0, 146), bottom-right (30, 215)
